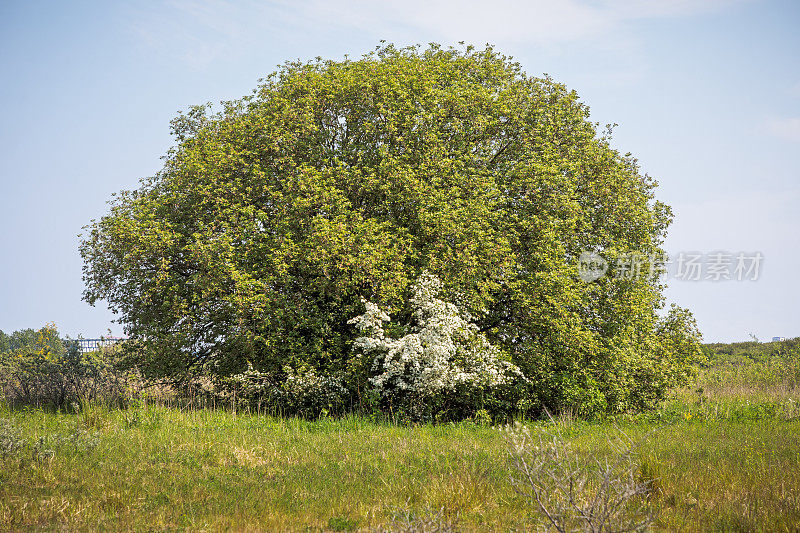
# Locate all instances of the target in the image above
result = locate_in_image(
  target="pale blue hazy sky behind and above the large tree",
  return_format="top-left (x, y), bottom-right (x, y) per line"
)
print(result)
top-left (0, 0), bottom-right (800, 341)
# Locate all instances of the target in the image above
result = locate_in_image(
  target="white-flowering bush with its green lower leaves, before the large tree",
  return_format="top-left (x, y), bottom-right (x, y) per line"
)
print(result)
top-left (350, 271), bottom-right (525, 418)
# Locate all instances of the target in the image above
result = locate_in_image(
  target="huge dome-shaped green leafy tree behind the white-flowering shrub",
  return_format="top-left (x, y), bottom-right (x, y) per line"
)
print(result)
top-left (81, 45), bottom-right (698, 410)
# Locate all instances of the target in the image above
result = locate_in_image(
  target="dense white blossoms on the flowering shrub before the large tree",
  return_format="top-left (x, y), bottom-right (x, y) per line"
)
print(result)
top-left (349, 271), bottom-right (522, 396)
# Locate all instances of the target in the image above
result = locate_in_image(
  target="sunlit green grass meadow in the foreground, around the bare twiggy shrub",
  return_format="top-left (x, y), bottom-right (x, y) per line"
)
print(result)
top-left (0, 338), bottom-right (800, 532)
